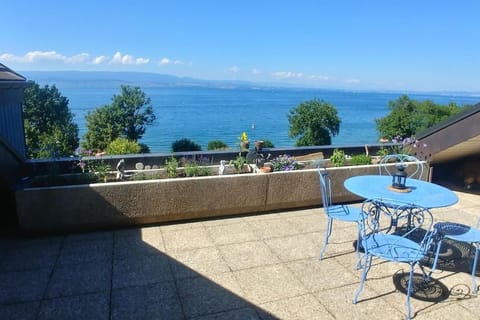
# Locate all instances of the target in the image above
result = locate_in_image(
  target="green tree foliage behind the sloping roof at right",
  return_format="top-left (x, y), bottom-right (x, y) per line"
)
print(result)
top-left (375, 95), bottom-right (465, 140)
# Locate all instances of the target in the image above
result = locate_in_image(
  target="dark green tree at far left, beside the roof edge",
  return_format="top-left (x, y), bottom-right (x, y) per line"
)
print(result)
top-left (23, 81), bottom-right (79, 159)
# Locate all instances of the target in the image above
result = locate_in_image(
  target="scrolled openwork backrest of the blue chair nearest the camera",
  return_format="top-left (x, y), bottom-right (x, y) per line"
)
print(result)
top-left (360, 199), bottom-right (434, 262)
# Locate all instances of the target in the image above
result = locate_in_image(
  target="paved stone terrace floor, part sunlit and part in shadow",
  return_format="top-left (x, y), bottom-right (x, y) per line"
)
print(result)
top-left (0, 189), bottom-right (480, 320)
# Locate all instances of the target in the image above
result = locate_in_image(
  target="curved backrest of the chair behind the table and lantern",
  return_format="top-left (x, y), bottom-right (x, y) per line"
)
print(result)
top-left (378, 154), bottom-right (423, 180)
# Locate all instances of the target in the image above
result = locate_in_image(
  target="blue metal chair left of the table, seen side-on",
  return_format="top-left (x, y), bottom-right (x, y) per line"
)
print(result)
top-left (318, 168), bottom-right (363, 260)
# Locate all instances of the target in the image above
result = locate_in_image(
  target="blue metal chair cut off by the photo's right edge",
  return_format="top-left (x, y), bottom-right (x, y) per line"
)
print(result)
top-left (432, 219), bottom-right (480, 294)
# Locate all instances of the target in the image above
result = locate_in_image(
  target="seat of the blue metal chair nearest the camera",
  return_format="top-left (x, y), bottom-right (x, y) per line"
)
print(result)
top-left (362, 233), bottom-right (424, 262)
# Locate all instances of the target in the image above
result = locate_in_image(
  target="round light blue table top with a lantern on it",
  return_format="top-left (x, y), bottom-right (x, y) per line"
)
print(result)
top-left (344, 175), bottom-right (458, 208)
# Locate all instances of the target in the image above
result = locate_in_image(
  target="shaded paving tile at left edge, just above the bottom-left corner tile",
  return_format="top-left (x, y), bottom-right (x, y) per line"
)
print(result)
top-left (0, 268), bottom-right (51, 305)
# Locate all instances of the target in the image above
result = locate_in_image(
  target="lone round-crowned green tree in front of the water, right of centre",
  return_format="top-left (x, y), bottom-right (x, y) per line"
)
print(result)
top-left (288, 99), bottom-right (341, 146)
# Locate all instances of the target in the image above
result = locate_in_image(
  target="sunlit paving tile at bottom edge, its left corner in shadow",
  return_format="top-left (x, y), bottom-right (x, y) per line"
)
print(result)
top-left (260, 294), bottom-right (335, 320)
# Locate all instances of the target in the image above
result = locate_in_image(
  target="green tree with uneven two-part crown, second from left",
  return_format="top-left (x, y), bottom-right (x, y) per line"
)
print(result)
top-left (83, 85), bottom-right (156, 150)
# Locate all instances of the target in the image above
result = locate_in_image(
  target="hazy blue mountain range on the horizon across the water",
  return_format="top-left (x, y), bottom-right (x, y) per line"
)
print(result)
top-left (18, 71), bottom-right (282, 88)
